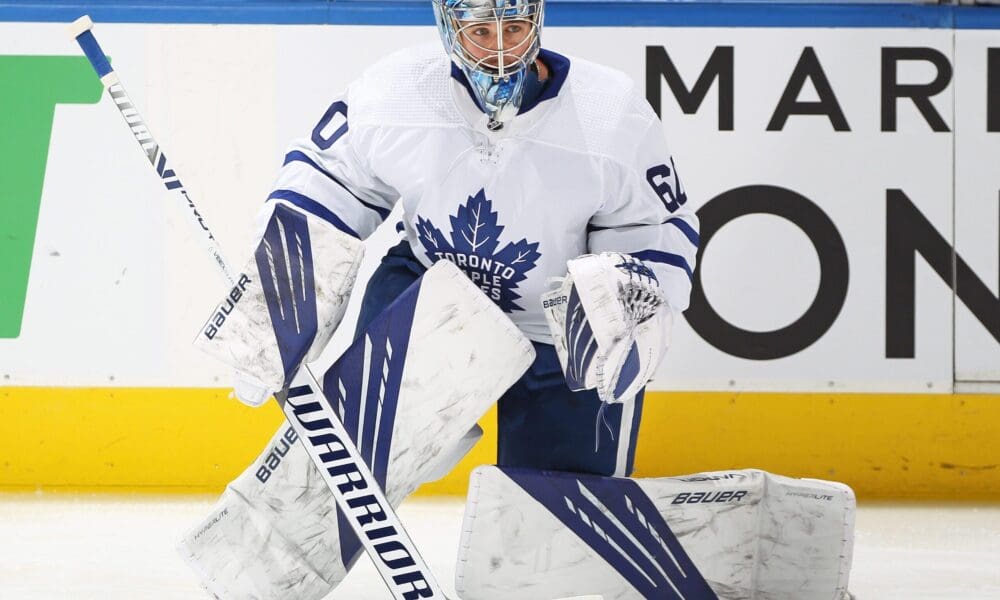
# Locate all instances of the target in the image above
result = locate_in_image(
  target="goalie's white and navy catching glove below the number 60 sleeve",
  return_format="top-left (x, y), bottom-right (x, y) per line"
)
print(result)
top-left (542, 252), bottom-right (673, 403)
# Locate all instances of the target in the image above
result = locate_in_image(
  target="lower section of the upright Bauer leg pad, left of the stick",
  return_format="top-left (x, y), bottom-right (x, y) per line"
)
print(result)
top-left (179, 424), bottom-right (338, 600)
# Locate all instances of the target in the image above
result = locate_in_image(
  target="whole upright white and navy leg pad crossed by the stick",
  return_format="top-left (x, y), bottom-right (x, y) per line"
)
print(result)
top-left (181, 261), bottom-right (534, 599)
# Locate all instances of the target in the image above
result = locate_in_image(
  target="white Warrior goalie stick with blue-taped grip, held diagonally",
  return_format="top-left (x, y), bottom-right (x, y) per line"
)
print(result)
top-left (70, 16), bottom-right (446, 600)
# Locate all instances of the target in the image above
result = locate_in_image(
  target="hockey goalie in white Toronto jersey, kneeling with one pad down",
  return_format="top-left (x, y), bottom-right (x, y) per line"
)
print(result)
top-left (181, 0), bottom-right (853, 600)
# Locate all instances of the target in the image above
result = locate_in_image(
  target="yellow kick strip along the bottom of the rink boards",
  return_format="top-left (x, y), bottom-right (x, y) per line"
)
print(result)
top-left (0, 387), bottom-right (1000, 500)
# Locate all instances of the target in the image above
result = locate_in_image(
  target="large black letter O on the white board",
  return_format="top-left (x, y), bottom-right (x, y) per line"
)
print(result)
top-left (684, 185), bottom-right (849, 360)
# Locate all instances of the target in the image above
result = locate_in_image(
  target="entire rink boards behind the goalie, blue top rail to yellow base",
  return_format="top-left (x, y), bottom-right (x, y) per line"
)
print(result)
top-left (0, 2), bottom-right (1000, 498)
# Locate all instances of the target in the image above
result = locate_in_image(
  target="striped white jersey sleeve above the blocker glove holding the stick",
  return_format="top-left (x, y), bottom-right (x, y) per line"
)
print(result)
top-left (258, 90), bottom-right (399, 240)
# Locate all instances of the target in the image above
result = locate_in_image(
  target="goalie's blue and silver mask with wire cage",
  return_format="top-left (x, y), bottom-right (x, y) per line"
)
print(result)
top-left (433, 0), bottom-right (544, 130)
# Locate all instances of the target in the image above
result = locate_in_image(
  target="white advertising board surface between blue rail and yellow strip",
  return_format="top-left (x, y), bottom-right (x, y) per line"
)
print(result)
top-left (0, 23), bottom-right (1000, 392)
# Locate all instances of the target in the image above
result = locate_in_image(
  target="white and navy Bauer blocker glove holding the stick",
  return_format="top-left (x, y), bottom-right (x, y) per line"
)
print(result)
top-left (195, 201), bottom-right (364, 406)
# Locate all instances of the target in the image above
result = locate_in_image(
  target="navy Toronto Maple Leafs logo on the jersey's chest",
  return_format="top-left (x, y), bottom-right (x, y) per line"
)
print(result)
top-left (417, 189), bottom-right (542, 312)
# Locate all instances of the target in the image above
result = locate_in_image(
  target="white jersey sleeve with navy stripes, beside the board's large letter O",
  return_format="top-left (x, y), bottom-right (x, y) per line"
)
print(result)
top-left (588, 117), bottom-right (698, 311)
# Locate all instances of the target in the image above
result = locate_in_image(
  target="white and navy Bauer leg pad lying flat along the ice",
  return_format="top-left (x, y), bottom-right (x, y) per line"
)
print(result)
top-left (456, 467), bottom-right (855, 600)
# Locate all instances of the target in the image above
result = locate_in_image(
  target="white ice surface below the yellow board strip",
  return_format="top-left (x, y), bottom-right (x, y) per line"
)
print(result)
top-left (0, 493), bottom-right (1000, 600)
